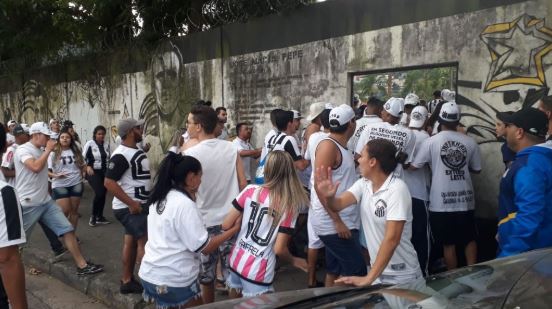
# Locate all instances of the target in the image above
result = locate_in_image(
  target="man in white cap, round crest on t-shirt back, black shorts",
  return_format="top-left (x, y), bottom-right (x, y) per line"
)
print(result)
top-left (411, 102), bottom-right (481, 269)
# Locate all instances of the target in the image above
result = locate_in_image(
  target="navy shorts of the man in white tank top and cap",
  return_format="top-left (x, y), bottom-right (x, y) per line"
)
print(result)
top-left (318, 230), bottom-right (367, 276)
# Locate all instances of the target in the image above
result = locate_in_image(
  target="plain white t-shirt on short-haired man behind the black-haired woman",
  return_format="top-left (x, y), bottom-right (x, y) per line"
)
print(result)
top-left (184, 138), bottom-right (240, 227)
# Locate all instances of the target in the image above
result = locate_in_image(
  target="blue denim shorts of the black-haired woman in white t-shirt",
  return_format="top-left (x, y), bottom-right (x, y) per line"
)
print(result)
top-left (142, 279), bottom-right (201, 308)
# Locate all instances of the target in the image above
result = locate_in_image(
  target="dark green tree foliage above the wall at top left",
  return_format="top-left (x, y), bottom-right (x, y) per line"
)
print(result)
top-left (0, 0), bottom-right (314, 61)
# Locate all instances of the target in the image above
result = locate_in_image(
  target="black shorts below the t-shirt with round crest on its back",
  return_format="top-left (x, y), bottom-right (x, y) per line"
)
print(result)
top-left (429, 210), bottom-right (477, 246)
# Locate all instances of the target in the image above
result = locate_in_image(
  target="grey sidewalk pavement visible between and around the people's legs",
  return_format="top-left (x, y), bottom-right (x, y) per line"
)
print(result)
top-left (23, 185), bottom-right (307, 309)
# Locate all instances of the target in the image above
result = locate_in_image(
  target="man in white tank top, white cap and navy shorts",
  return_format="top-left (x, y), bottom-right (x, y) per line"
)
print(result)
top-left (311, 104), bottom-right (366, 287)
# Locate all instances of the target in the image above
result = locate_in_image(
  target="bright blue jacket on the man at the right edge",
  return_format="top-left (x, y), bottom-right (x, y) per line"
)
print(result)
top-left (498, 142), bottom-right (552, 257)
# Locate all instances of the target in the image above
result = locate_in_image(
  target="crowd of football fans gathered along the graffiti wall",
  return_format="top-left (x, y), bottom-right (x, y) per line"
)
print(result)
top-left (0, 89), bottom-right (552, 308)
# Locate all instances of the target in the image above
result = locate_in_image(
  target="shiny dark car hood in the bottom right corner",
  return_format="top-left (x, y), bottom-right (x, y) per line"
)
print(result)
top-left (198, 249), bottom-right (552, 308)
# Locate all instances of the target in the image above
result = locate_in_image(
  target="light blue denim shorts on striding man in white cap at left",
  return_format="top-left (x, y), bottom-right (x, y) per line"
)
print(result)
top-left (22, 200), bottom-right (73, 237)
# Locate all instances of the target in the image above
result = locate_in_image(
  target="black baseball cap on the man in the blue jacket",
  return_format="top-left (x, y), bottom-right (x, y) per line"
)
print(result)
top-left (496, 107), bottom-right (548, 138)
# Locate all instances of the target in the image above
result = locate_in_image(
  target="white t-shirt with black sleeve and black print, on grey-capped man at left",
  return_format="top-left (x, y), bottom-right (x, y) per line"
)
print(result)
top-left (105, 144), bottom-right (151, 209)
